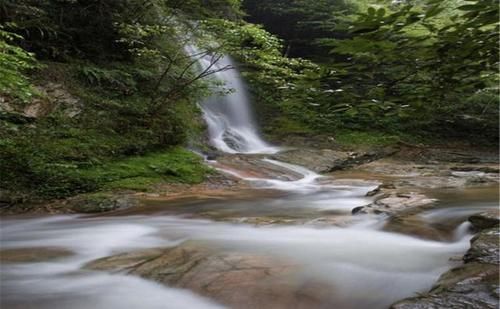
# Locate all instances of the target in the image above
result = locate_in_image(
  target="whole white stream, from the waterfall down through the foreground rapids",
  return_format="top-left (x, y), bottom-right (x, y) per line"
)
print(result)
top-left (0, 51), bottom-right (496, 309)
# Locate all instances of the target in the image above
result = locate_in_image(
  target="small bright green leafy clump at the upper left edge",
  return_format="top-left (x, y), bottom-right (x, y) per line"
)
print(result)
top-left (0, 26), bottom-right (38, 101)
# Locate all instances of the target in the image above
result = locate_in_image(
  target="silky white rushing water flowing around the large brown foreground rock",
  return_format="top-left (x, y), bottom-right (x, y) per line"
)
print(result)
top-left (0, 216), bottom-right (469, 309)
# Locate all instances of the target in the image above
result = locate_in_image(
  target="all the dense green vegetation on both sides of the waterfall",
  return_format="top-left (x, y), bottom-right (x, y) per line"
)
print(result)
top-left (0, 0), bottom-right (499, 202)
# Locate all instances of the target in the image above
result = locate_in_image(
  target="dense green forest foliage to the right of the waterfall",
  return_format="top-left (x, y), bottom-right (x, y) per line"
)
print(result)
top-left (245, 0), bottom-right (499, 144)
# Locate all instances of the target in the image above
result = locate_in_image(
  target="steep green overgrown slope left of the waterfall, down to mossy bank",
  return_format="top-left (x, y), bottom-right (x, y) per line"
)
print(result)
top-left (0, 0), bottom-right (239, 198)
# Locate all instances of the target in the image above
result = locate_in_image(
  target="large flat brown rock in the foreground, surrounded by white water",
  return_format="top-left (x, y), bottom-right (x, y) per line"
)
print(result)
top-left (86, 242), bottom-right (332, 309)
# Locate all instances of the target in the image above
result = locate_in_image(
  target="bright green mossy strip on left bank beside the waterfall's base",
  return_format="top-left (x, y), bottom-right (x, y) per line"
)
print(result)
top-left (34, 147), bottom-right (210, 198)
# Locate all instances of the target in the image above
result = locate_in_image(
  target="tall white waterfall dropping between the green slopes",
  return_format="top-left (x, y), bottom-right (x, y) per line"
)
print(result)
top-left (186, 46), bottom-right (279, 153)
